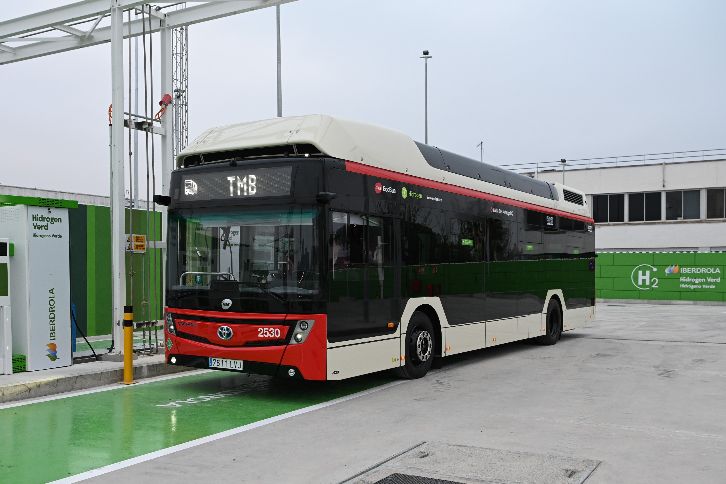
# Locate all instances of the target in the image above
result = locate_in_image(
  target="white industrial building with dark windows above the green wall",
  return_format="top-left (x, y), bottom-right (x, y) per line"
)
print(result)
top-left (529, 154), bottom-right (726, 252)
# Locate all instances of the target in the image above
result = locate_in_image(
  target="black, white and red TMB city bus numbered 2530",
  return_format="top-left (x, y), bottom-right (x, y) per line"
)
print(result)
top-left (161, 115), bottom-right (595, 380)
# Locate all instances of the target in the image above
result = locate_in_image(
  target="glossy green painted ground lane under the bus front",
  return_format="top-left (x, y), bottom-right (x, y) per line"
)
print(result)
top-left (0, 372), bottom-right (390, 483)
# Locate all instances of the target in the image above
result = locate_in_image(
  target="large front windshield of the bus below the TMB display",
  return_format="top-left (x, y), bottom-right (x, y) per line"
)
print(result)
top-left (168, 207), bottom-right (319, 301)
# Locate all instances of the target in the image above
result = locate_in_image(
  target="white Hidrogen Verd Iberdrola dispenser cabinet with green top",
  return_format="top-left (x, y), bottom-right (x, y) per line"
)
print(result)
top-left (0, 197), bottom-right (73, 371)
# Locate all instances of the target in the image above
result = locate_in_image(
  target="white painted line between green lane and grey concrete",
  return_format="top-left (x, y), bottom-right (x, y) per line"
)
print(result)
top-left (52, 380), bottom-right (409, 484)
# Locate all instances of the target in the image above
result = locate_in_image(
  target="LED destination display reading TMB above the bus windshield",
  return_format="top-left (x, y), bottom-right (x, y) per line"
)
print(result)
top-left (174, 166), bottom-right (292, 201)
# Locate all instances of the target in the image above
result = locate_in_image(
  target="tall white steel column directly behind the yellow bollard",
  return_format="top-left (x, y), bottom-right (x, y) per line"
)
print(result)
top-left (110, 0), bottom-right (126, 354)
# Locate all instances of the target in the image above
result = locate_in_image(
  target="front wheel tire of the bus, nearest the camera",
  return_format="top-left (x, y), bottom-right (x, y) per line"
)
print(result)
top-left (397, 311), bottom-right (436, 380)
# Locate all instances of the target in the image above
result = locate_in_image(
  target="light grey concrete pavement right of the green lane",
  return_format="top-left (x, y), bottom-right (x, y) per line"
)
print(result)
top-left (97, 304), bottom-right (726, 484)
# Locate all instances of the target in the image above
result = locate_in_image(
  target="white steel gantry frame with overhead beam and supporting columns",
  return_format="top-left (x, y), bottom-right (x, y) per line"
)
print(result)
top-left (0, 0), bottom-right (295, 352)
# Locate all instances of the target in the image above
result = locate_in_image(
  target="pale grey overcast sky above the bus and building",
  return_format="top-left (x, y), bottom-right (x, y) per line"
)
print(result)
top-left (0, 0), bottom-right (726, 194)
